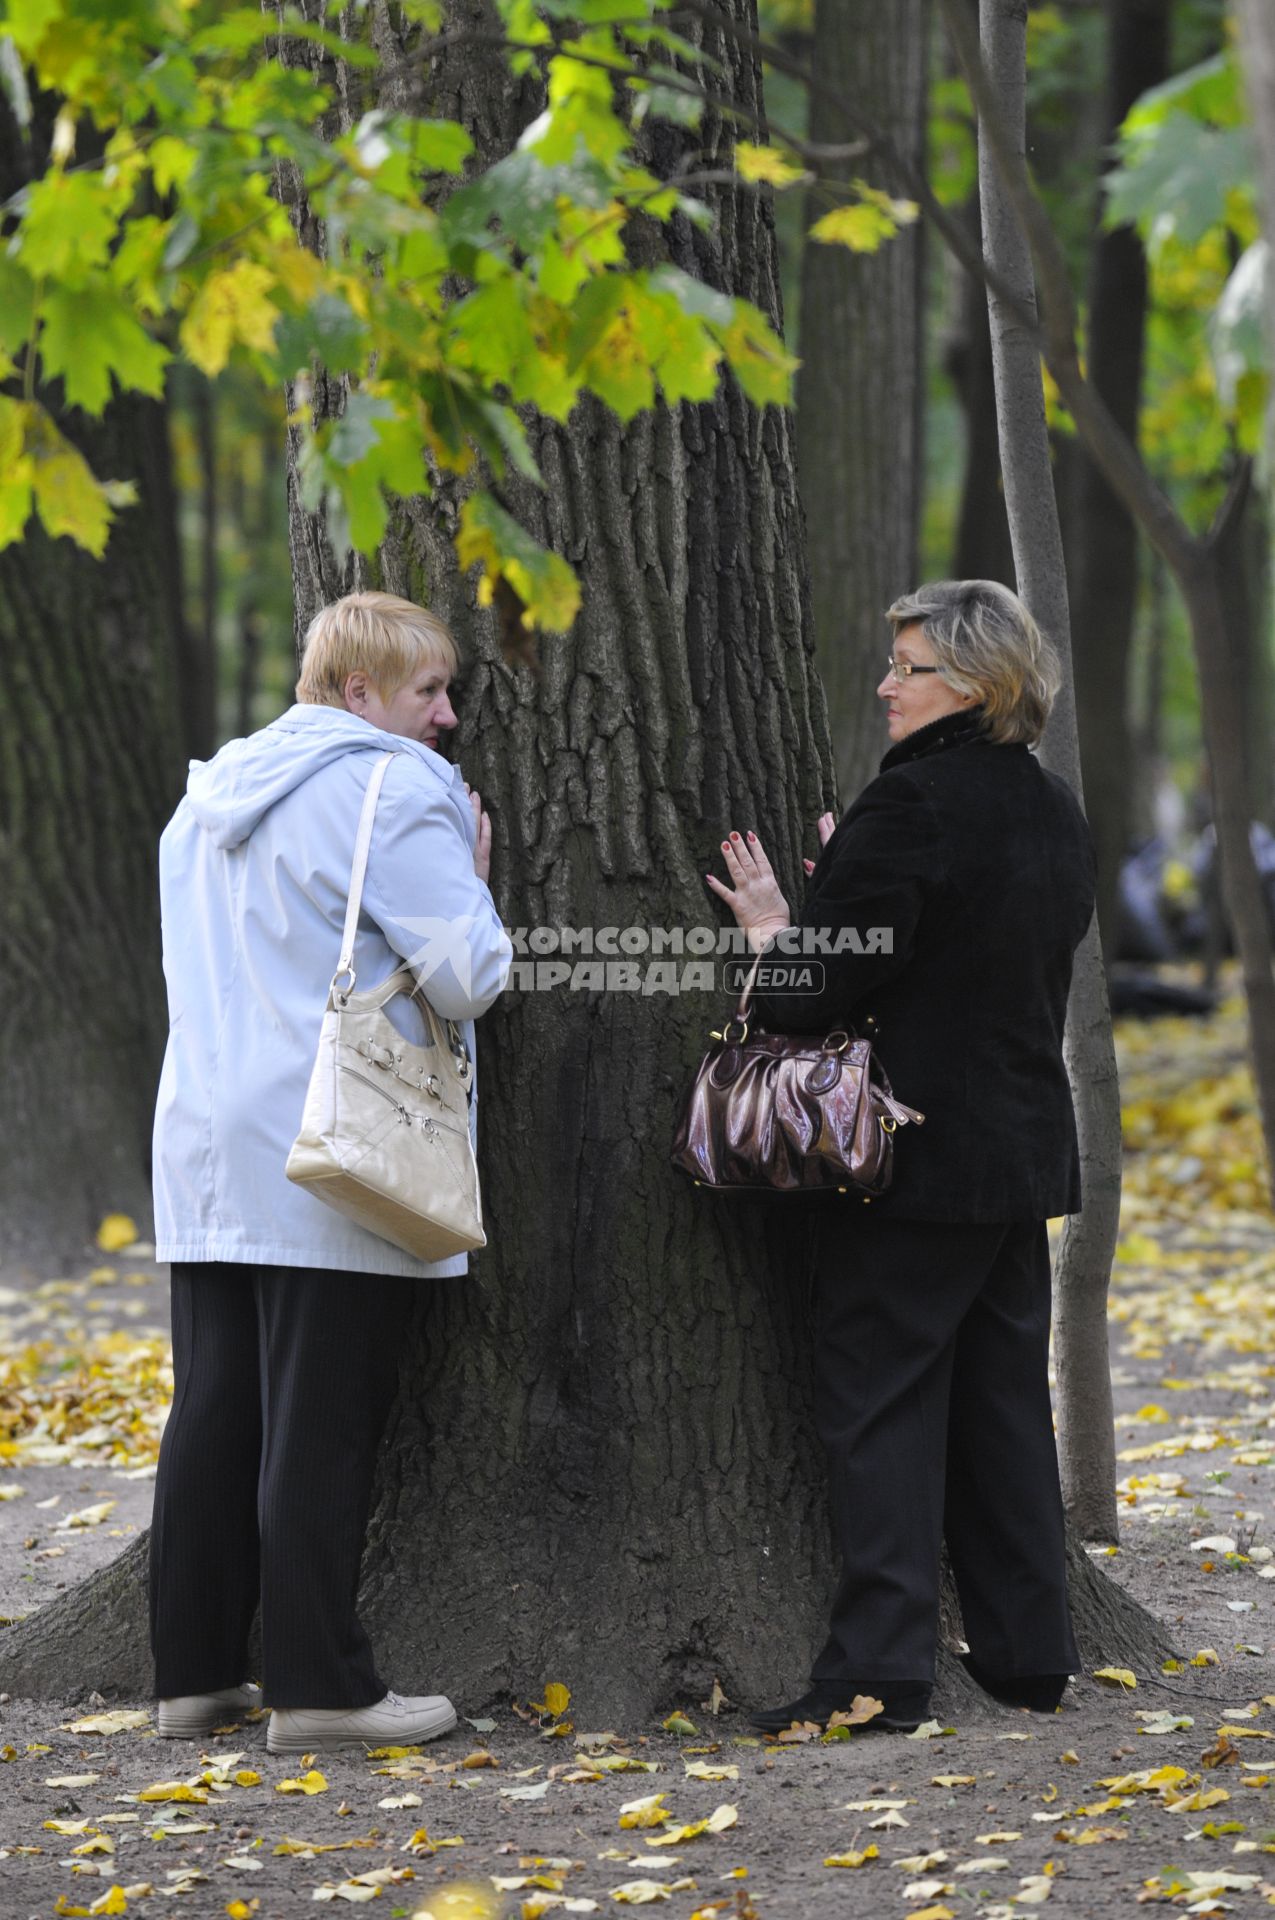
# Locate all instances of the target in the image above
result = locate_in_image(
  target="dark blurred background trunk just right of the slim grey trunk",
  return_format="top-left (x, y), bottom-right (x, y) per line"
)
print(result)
top-left (1071, 0), bottom-right (1171, 962)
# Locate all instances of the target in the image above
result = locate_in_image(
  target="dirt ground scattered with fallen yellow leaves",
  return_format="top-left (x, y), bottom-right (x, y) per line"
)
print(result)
top-left (0, 998), bottom-right (1275, 1920)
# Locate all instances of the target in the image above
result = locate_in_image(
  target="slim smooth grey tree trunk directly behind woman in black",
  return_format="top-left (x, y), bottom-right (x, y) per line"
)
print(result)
top-left (979, 0), bottom-right (1119, 1540)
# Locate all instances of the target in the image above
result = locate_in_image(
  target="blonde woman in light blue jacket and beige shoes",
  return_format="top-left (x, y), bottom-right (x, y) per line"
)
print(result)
top-left (150, 593), bottom-right (511, 1753)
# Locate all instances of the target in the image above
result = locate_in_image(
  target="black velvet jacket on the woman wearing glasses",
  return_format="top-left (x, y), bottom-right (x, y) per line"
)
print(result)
top-left (755, 714), bottom-right (1095, 1221)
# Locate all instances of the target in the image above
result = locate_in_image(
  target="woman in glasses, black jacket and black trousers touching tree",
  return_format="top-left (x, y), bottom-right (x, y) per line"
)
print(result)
top-left (709, 580), bottom-right (1095, 1730)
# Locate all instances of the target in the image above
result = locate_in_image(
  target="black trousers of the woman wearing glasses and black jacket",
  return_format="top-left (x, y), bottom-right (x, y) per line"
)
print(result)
top-left (814, 1208), bottom-right (1079, 1682)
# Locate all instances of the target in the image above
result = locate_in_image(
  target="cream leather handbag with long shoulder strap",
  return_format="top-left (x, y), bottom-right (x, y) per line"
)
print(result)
top-left (286, 753), bottom-right (488, 1260)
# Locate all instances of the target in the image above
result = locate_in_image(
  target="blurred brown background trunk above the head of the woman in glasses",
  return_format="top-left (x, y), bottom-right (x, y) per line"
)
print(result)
top-left (797, 0), bottom-right (929, 804)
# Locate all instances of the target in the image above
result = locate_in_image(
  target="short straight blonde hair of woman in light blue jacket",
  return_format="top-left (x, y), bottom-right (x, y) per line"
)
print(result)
top-left (296, 593), bottom-right (459, 707)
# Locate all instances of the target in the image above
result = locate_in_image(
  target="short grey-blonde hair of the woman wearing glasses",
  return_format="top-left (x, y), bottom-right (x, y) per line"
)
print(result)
top-left (885, 580), bottom-right (1062, 747)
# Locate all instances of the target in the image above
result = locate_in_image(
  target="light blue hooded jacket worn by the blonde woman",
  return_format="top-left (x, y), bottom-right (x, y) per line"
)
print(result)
top-left (154, 707), bottom-right (511, 1277)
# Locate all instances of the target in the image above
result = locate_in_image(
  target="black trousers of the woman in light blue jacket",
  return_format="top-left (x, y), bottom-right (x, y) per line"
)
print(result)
top-left (150, 1261), bottom-right (417, 1707)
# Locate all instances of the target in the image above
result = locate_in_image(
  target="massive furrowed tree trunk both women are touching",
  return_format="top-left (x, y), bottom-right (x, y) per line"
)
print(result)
top-left (0, 0), bottom-right (1162, 1724)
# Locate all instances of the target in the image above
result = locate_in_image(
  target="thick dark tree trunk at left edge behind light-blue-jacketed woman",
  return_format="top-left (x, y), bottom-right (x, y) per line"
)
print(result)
top-left (0, 109), bottom-right (182, 1260)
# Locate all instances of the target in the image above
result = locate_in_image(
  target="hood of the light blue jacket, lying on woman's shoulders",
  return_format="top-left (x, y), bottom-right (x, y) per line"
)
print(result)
top-left (186, 707), bottom-right (455, 847)
